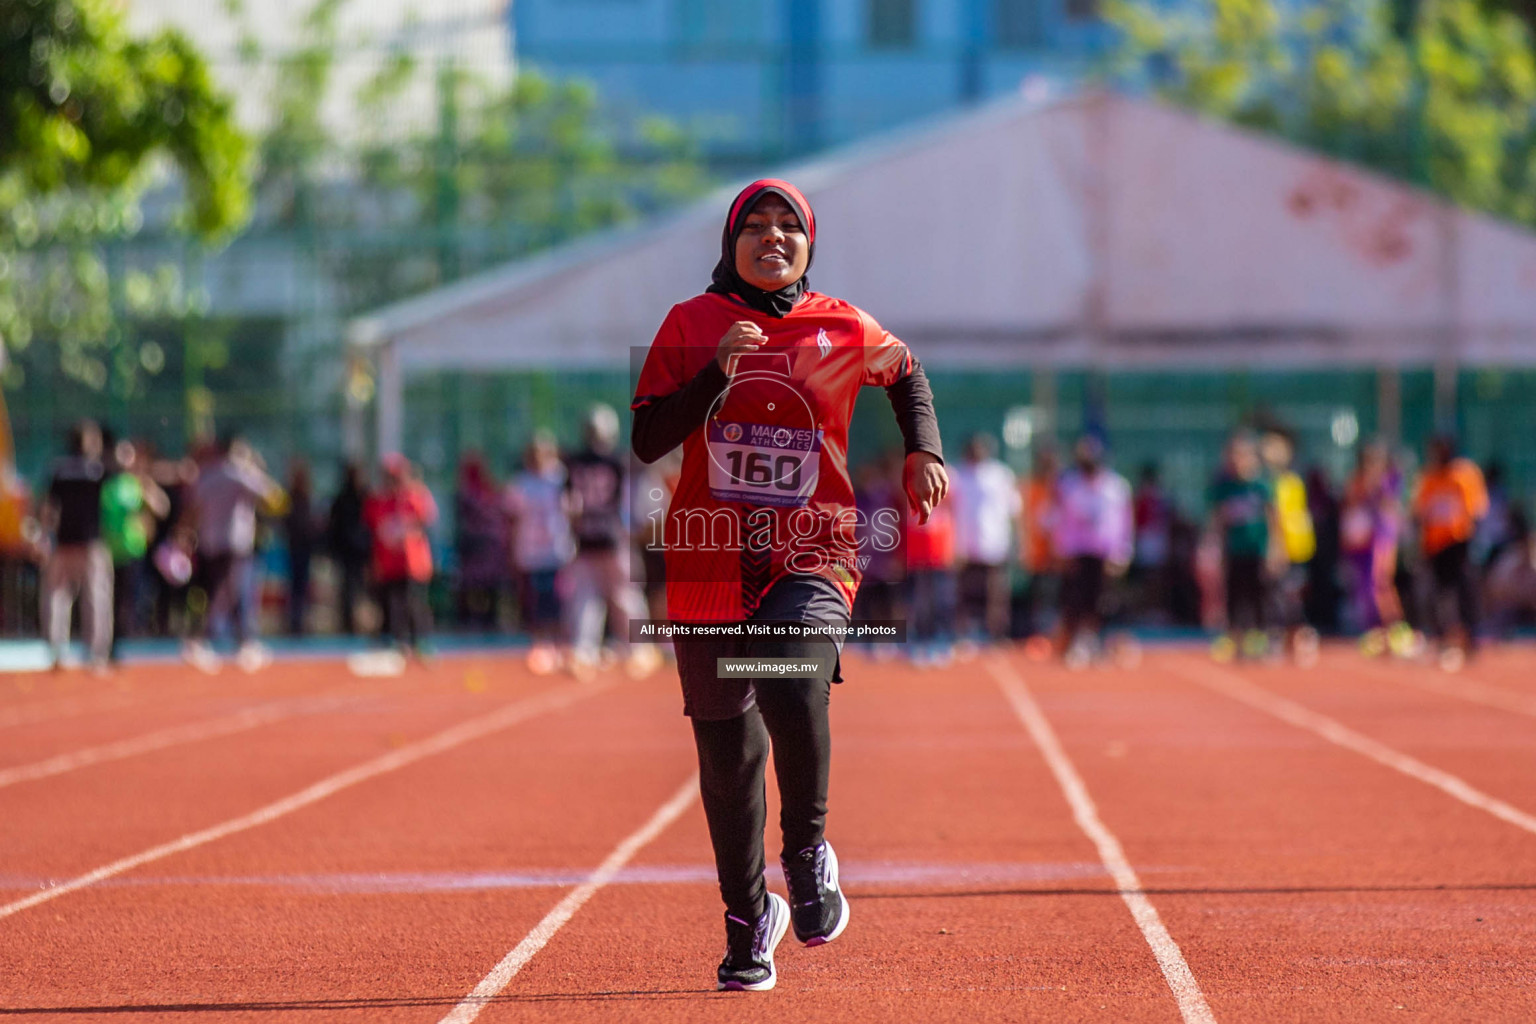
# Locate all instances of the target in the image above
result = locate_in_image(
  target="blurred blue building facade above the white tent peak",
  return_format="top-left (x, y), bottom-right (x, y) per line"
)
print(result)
top-left (511, 0), bottom-right (1107, 166)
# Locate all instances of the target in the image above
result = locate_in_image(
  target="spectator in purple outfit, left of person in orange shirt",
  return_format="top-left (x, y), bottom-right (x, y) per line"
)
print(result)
top-left (1339, 441), bottom-right (1402, 644)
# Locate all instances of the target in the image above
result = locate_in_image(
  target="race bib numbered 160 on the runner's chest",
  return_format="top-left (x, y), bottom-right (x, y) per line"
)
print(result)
top-left (705, 419), bottom-right (822, 508)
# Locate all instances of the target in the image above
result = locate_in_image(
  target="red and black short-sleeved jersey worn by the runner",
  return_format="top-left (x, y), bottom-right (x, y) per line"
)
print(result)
top-left (631, 292), bottom-right (915, 622)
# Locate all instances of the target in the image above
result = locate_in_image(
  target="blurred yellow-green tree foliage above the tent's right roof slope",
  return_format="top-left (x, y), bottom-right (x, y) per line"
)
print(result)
top-left (1104, 0), bottom-right (1536, 224)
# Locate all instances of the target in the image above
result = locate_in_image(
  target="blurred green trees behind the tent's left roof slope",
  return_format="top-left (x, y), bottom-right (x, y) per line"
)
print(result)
top-left (238, 0), bottom-right (708, 313)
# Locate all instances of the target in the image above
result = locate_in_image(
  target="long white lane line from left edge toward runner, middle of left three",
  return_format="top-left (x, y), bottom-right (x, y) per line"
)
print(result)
top-left (0, 679), bottom-right (617, 918)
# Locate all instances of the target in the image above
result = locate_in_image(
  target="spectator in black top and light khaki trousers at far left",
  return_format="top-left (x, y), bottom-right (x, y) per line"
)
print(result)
top-left (41, 419), bottom-right (112, 671)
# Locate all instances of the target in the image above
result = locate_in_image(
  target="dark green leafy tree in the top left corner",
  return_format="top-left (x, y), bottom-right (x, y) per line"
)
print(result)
top-left (0, 0), bottom-right (249, 387)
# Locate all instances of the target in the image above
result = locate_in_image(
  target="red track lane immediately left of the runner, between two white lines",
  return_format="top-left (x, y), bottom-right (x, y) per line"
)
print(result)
top-left (0, 669), bottom-right (691, 1021)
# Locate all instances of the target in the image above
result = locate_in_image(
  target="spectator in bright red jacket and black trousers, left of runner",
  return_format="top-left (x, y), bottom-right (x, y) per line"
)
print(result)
top-left (364, 453), bottom-right (438, 657)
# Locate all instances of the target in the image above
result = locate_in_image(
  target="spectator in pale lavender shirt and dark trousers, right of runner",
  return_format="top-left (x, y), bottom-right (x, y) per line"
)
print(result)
top-left (1055, 434), bottom-right (1134, 666)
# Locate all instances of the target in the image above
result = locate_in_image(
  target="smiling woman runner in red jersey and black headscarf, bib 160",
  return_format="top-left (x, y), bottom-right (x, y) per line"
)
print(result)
top-left (631, 180), bottom-right (949, 990)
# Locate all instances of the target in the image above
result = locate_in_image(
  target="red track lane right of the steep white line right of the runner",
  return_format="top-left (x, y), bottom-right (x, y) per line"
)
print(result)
top-left (1035, 654), bottom-right (1536, 1021)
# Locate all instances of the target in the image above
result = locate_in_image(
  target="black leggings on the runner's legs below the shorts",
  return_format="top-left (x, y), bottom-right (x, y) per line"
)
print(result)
top-left (691, 679), bottom-right (833, 921)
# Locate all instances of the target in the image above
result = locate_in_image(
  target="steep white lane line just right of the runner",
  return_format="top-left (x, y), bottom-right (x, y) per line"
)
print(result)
top-left (988, 657), bottom-right (1217, 1024)
